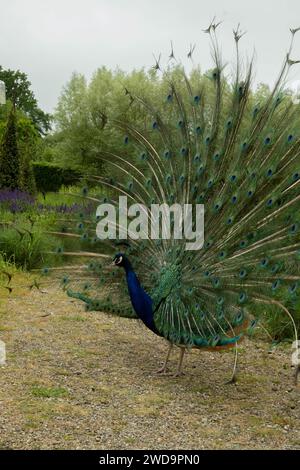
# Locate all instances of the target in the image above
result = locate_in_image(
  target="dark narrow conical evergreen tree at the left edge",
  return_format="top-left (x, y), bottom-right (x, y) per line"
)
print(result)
top-left (0, 108), bottom-right (20, 189)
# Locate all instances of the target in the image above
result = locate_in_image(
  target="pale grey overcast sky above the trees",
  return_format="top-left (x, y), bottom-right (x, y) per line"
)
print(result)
top-left (0, 0), bottom-right (300, 112)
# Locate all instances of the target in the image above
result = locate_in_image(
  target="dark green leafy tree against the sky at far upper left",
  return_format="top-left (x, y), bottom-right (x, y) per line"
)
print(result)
top-left (0, 65), bottom-right (51, 135)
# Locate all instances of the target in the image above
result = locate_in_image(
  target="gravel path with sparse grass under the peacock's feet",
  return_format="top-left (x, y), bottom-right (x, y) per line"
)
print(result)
top-left (0, 278), bottom-right (300, 449)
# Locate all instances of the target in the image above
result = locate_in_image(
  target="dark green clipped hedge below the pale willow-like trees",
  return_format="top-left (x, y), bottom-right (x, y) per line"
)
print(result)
top-left (33, 162), bottom-right (81, 193)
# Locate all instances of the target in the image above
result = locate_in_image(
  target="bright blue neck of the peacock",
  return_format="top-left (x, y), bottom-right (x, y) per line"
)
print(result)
top-left (124, 261), bottom-right (157, 333)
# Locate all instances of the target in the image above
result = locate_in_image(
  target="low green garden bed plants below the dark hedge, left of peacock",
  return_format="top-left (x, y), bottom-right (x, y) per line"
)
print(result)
top-left (0, 187), bottom-right (95, 270)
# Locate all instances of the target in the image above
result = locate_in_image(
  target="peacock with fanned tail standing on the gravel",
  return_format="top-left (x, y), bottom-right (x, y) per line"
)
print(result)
top-left (39, 20), bottom-right (300, 382)
